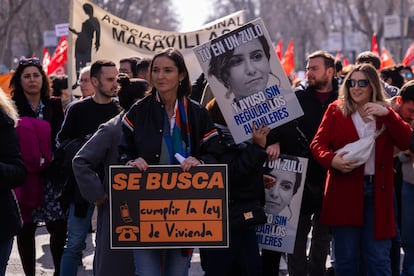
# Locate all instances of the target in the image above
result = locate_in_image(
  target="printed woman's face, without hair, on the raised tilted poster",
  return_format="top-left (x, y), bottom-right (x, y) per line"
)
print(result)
top-left (229, 39), bottom-right (270, 100)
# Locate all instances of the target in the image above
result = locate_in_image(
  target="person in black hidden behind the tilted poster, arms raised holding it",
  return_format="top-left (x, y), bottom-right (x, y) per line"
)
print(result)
top-left (201, 98), bottom-right (270, 276)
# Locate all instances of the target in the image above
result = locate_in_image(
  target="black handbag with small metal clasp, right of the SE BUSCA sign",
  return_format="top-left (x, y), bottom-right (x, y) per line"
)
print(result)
top-left (229, 200), bottom-right (267, 229)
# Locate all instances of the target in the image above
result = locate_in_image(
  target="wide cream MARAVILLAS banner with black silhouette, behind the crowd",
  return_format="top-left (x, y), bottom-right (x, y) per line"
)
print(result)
top-left (68, 0), bottom-right (245, 83)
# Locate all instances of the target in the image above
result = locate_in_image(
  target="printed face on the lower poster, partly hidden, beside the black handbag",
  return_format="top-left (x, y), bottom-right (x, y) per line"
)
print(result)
top-left (265, 170), bottom-right (296, 215)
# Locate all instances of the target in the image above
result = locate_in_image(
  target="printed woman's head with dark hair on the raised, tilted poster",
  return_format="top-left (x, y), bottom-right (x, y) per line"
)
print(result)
top-left (208, 23), bottom-right (280, 102)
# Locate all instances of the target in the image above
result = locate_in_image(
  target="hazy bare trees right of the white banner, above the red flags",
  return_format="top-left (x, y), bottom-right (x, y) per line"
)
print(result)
top-left (210, 0), bottom-right (414, 69)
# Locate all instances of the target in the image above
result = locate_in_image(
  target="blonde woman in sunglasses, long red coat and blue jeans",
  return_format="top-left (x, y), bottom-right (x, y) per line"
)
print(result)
top-left (311, 64), bottom-right (411, 276)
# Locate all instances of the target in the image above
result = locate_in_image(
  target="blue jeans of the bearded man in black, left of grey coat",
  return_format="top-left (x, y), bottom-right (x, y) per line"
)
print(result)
top-left (60, 203), bottom-right (94, 276)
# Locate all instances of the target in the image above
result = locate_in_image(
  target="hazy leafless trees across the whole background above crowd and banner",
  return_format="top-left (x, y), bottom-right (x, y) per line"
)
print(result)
top-left (0, 0), bottom-right (414, 72)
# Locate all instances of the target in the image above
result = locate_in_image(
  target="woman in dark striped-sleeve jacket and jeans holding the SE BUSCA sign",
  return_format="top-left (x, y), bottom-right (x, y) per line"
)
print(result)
top-left (119, 48), bottom-right (219, 276)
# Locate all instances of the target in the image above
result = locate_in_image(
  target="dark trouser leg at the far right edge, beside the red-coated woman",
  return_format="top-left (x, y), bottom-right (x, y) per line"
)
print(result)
top-left (401, 181), bottom-right (414, 276)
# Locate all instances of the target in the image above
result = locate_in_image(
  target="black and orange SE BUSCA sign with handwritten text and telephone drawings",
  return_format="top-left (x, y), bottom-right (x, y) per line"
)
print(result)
top-left (109, 165), bottom-right (229, 249)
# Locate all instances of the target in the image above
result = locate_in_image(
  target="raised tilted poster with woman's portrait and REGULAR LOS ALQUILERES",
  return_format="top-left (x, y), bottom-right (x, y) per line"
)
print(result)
top-left (194, 18), bottom-right (303, 143)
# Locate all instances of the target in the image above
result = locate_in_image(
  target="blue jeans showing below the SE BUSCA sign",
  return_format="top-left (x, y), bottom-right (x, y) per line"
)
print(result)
top-left (134, 249), bottom-right (191, 276)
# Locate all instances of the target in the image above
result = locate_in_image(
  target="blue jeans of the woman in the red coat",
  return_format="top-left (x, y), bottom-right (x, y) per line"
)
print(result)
top-left (332, 182), bottom-right (391, 276)
